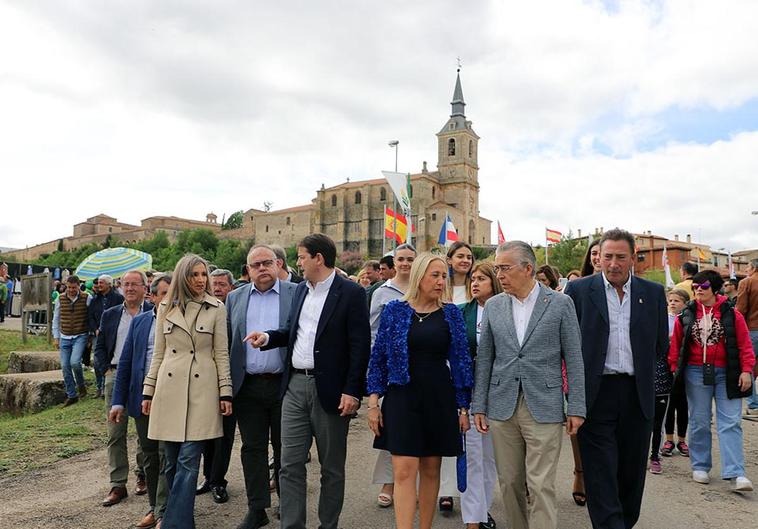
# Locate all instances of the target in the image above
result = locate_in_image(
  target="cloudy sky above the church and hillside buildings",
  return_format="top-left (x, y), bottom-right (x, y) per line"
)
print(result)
top-left (0, 0), bottom-right (758, 250)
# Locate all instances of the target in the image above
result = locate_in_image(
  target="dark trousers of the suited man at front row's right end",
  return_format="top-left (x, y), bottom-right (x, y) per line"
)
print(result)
top-left (578, 375), bottom-right (653, 529)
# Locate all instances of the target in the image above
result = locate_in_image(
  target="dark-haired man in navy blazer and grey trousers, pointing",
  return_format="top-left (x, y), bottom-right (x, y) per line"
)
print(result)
top-left (246, 233), bottom-right (370, 529)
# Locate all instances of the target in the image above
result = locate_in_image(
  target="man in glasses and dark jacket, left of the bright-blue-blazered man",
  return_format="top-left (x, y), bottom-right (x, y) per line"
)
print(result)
top-left (95, 270), bottom-right (153, 507)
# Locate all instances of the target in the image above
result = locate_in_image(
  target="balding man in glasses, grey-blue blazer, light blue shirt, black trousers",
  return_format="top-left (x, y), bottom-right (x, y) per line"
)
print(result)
top-left (226, 245), bottom-right (296, 529)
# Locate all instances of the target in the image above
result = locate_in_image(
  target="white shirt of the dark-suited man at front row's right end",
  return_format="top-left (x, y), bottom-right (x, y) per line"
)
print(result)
top-left (602, 273), bottom-right (634, 375)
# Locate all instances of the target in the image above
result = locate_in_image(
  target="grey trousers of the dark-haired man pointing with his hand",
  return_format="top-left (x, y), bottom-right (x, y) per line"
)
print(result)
top-left (279, 373), bottom-right (350, 529)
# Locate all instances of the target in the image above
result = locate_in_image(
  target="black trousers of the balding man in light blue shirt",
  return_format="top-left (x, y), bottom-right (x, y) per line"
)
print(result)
top-left (233, 375), bottom-right (282, 510)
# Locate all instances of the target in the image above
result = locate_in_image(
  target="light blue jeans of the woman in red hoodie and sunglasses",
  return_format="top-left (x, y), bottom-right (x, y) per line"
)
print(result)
top-left (685, 366), bottom-right (745, 479)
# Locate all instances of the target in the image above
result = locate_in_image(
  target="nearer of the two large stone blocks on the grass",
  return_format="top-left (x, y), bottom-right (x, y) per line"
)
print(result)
top-left (0, 370), bottom-right (66, 412)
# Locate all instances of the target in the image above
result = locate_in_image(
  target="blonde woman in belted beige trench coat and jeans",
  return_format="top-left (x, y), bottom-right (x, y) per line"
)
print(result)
top-left (142, 254), bottom-right (232, 529)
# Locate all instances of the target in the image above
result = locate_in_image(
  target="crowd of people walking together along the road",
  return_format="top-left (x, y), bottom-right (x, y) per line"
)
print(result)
top-left (13, 229), bottom-right (758, 529)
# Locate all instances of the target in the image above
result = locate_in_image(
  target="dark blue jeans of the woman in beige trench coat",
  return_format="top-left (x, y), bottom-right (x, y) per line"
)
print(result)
top-left (161, 441), bottom-right (205, 529)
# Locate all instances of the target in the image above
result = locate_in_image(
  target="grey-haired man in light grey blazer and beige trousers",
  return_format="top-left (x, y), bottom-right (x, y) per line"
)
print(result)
top-left (471, 241), bottom-right (585, 529)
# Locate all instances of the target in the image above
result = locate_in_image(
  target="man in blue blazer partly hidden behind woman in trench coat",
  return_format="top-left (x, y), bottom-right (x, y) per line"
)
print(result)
top-left (108, 275), bottom-right (171, 528)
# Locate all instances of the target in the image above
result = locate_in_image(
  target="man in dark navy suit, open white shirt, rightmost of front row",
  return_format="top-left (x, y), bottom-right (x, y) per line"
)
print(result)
top-left (566, 228), bottom-right (668, 529)
